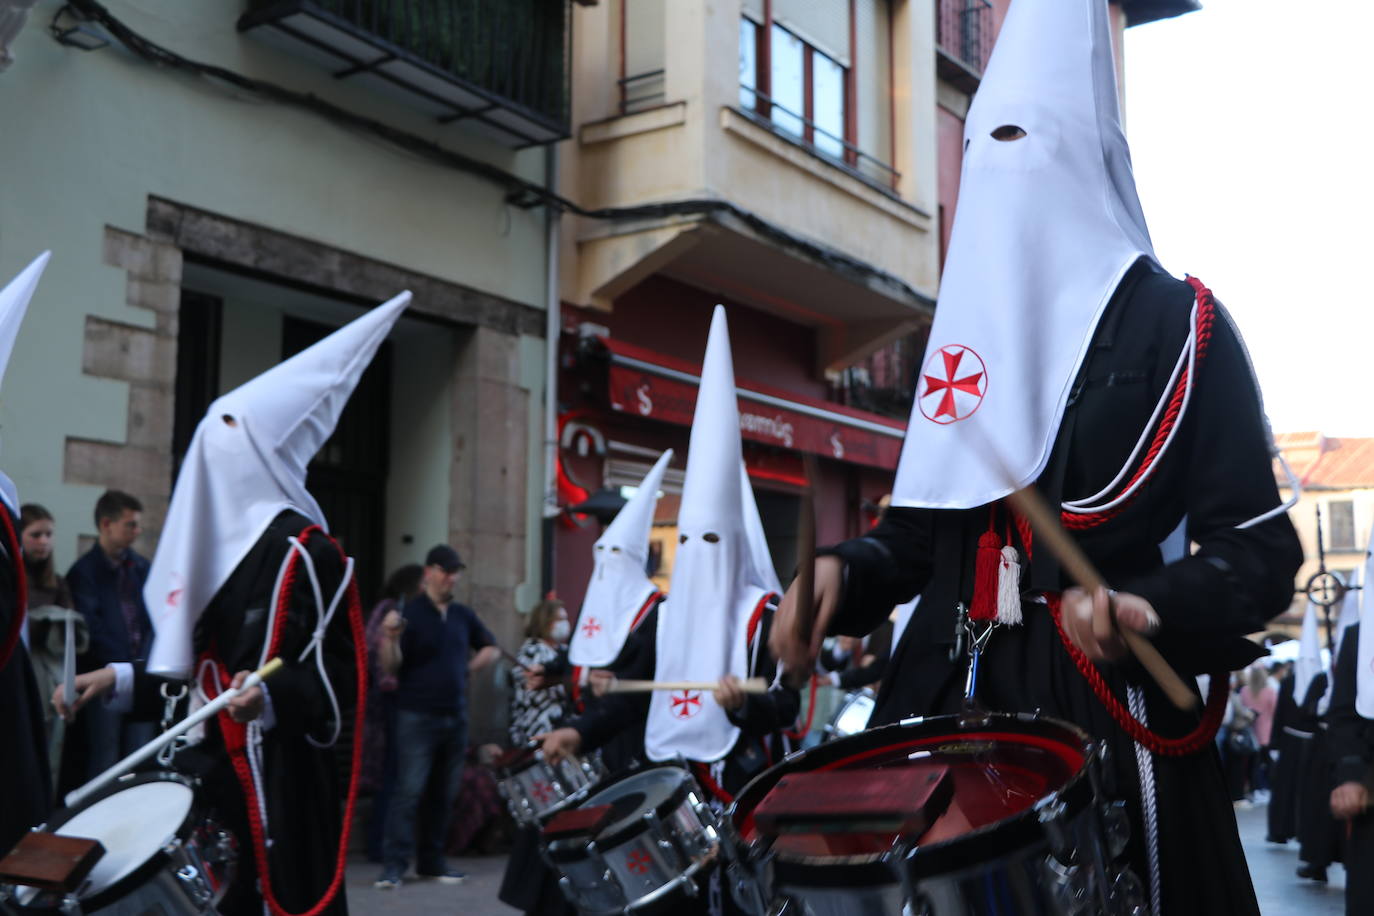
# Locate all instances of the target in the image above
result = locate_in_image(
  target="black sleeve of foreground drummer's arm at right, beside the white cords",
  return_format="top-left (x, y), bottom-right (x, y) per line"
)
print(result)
top-left (1118, 308), bottom-right (1303, 655)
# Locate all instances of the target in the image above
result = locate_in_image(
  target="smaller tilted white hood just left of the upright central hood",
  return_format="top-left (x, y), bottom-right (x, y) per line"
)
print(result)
top-left (567, 449), bottom-right (673, 667)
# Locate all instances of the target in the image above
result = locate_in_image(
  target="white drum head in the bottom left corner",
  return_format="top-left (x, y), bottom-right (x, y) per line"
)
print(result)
top-left (52, 779), bottom-right (195, 900)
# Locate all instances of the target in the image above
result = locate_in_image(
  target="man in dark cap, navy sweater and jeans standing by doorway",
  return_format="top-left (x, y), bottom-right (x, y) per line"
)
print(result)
top-left (376, 544), bottom-right (500, 890)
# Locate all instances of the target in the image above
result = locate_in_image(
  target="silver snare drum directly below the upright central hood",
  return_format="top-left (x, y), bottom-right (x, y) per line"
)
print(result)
top-left (544, 765), bottom-right (720, 916)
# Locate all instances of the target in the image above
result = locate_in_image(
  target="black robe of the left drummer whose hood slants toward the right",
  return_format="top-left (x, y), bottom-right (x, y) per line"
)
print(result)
top-left (135, 511), bottom-right (359, 916)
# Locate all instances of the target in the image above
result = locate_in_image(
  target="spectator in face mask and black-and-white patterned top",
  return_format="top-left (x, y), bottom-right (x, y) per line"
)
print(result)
top-left (510, 597), bottom-right (572, 746)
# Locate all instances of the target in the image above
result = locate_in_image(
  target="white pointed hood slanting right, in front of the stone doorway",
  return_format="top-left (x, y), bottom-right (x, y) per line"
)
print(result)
top-left (143, 293), bottom-right (411, 677)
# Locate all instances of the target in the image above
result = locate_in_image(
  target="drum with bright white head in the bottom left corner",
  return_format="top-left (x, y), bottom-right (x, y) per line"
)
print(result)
top-left (3, 770), bottom-right (238, 916)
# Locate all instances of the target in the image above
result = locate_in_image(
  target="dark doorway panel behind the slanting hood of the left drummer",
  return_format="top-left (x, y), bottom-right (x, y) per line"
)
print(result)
top-left (282, 316), bottom-right (392, 607)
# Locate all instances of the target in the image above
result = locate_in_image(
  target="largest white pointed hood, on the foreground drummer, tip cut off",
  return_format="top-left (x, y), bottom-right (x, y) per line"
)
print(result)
top-left (892, 0), bottom-right (1154, 508)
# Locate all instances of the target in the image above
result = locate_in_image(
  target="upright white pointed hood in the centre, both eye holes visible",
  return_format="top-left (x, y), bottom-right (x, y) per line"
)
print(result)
top-left (644, 305), bottom-right (769, 761)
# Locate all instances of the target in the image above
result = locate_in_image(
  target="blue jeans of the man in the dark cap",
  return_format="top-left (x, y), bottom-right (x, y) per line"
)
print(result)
top-left (382, 709), bottom-right (467, 875)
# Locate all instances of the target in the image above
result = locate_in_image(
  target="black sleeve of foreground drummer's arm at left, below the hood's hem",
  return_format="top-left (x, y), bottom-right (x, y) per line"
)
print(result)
top-left (816, 508), bottom-right (932, 636)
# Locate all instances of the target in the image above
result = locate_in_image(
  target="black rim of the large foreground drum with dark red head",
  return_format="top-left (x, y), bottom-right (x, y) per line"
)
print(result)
top-left (721, 713), bottom-right (1098, 883)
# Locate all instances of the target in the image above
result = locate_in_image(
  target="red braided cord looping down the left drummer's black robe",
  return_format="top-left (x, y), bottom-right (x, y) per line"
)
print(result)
top-left (220, 525), bottom-right (367, 916)
